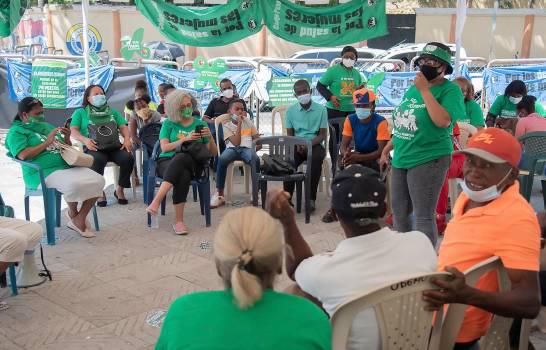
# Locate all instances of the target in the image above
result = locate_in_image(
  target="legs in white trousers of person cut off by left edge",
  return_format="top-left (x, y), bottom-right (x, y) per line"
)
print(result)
top-left (0, 216), bottom-right (43, 311)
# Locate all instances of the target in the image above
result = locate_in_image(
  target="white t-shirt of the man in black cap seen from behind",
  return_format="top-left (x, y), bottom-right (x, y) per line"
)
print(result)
top-left (295, 227), bottom-right (436, 350)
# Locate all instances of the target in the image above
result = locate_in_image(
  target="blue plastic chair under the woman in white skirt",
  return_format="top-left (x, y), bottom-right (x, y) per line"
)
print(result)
top-left (12, 158), bottom-right (99, 245)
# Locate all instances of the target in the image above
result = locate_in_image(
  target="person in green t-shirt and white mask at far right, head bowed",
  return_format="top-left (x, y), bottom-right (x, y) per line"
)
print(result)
top-left (485, 80), bottom-right (546, 131)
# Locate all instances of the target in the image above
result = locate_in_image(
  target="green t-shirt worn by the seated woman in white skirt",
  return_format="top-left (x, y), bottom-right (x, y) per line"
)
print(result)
top-left (6, 120), bottom-right (70, 189)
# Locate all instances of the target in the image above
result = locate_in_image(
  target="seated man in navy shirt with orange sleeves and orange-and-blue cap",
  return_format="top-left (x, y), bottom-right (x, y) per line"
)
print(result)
top-left (322, 88), bottom-right (391, 223)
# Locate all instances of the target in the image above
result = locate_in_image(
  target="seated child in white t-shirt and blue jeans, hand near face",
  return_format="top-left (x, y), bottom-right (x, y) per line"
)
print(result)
top-left (210, 99), bottom-right (259, 209)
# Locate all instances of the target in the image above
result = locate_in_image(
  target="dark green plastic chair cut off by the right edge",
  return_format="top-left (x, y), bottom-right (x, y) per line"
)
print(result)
top-left (518, 131), bottom-right (546, 207)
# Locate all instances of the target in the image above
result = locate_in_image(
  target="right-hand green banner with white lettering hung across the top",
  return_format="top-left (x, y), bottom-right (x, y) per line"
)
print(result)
top-left (260, 0), bottom-right (387, 46)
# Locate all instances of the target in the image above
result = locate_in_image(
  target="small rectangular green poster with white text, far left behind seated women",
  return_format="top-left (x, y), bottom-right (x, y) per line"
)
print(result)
top-left (32, 61), bottom-right (67, 108)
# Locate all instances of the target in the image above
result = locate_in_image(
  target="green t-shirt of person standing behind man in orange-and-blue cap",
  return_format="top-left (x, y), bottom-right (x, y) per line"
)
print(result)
top-left (319, 64), bottom-right (363, 112)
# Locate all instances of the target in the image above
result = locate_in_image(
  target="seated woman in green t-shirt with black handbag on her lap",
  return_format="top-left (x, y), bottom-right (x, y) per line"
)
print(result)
top-left (70, 85), bottom-right (135, 207)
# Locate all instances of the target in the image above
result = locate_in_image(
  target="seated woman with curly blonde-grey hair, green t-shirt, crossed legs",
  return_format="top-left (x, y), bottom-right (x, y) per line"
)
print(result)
top-left (146, 90), bottom-right (217, 235)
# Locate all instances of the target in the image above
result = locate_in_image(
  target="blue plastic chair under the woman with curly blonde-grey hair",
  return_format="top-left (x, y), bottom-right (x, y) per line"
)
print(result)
top-left (143, 141), bottom-right (211, 227)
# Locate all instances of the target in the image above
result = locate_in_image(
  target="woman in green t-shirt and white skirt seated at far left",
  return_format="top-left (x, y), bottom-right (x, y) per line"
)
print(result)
top-left (6, 97), bottom-right (104, 238)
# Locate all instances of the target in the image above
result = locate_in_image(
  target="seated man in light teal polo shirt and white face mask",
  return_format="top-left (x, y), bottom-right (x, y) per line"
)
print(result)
top-left (284, 79), bottom-right (328, 211)
